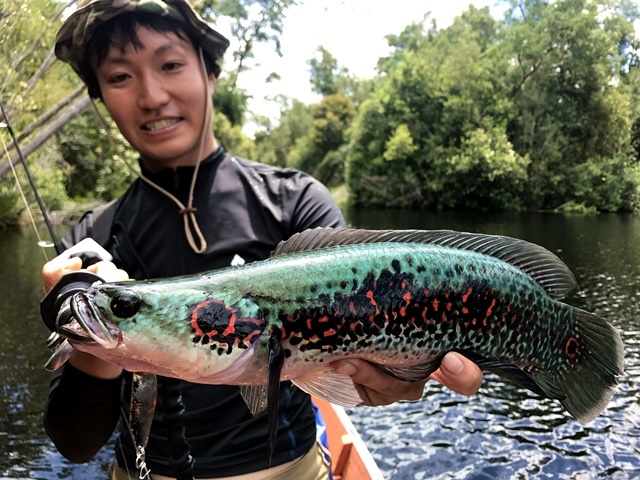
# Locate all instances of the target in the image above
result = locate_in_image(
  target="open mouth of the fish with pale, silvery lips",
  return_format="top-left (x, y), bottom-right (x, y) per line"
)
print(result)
top-left (58, 292), bottom-right (122, 350)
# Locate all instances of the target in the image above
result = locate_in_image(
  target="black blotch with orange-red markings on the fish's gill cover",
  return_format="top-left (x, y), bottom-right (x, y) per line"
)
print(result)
top-left (190, 299), bottom-right (265, 355)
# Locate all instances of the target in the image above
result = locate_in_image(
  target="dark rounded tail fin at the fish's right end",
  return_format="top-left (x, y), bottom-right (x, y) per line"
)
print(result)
top-left (532, 308), bottom-right (624, 424)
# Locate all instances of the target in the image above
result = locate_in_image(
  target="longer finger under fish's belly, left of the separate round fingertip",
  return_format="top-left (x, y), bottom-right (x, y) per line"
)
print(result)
top-left (334, 359), bottom-right (426, 406)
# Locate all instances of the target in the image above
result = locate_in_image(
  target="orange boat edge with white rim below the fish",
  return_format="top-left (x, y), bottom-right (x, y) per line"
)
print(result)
top-left (311, 396), bottom-right (384, 480)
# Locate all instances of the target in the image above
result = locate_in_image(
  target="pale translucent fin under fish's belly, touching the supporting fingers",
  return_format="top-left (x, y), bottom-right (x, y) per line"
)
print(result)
top-left (291, 368), bottom-right (362, 407)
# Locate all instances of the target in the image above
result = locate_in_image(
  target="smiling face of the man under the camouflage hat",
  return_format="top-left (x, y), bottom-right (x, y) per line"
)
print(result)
top-left (96, 27), bottom-right (217, 171)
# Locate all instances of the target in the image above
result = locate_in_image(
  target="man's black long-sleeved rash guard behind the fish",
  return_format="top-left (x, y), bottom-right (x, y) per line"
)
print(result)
top-left (45, 148), bottom-right (344, 478)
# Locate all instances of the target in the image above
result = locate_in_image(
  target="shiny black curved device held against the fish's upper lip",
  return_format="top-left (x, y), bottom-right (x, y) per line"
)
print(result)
top-left (40, 270), bottom-right (104, 333)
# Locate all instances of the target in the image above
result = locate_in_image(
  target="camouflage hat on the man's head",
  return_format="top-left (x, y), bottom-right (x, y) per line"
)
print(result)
top-left (55, 0), bottom-right (229, 81)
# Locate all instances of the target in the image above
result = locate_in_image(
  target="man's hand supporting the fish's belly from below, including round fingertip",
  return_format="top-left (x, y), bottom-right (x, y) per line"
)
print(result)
top-left (334, 352), bottom-right (482, 406)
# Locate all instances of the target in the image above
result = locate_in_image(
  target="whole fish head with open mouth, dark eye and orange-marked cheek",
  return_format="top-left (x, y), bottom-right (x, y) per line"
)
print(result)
top-left (59, 281), bottom-right (265, 383)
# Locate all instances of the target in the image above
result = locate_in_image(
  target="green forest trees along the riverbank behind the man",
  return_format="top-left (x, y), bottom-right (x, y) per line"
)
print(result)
top-left (0, 0), bottom-right (640, 225)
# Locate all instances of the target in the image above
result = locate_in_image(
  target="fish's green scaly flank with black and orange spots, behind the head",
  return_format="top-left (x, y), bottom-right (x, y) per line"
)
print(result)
top-left (232, 244), bottom-right (571, 374)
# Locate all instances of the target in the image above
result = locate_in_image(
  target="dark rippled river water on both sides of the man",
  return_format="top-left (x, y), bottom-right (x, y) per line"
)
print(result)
top-left (0, 212), bottom-right (640, 480)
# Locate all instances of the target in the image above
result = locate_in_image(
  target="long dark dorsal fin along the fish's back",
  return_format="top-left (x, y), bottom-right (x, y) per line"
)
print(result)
top-left (271, 227), bottom-right (578, 298)
